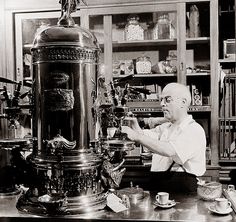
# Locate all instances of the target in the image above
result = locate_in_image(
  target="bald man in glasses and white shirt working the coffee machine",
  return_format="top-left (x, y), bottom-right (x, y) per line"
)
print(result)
top-left (122, 83), bottom-right (206, 192)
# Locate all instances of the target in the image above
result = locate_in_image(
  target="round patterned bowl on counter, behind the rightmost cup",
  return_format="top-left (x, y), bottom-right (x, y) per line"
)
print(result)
top-left (197, 181), bottom-right (222, 200)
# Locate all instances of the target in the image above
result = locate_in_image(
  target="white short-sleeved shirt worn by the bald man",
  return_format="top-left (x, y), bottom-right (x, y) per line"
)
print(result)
top-left (143, 115), bottom-right (206, 176)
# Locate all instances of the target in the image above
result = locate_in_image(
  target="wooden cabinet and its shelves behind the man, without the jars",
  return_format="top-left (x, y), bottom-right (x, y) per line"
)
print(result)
top-left (78, 0), bottom-right (219, 170)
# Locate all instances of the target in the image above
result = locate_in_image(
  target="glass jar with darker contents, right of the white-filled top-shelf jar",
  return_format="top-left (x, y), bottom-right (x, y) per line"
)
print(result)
top-left (153, 14), bottom-right (173, 40)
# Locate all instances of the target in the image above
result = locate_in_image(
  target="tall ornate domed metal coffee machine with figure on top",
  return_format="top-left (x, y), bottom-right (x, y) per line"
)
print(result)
top-left (17, 0), bottom-right (125, 215)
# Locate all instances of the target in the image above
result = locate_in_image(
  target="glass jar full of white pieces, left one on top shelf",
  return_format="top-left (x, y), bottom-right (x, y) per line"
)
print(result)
top-left (124, 14), bottom-right (144, 41)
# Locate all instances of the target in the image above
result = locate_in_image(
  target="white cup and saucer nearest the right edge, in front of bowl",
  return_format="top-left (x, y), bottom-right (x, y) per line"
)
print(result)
top-left (208, 197), bottom-right (233, 215)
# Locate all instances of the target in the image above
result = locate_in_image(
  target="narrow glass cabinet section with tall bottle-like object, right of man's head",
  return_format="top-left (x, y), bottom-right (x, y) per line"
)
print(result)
top-left (185, 2), bottom-right (211, 111)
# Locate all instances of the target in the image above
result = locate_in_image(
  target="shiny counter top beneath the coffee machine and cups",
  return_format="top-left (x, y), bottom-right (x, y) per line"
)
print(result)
top-left (0, 192), bottom-right (236, 222)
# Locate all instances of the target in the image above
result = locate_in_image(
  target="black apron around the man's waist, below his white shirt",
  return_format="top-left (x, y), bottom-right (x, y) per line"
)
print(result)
top-left (150, 162), bottom-right (197, 193)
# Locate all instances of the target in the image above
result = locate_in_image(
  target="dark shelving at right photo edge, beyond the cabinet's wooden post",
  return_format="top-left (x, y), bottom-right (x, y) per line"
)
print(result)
top-left (219, 0), bottom-right (236, 184)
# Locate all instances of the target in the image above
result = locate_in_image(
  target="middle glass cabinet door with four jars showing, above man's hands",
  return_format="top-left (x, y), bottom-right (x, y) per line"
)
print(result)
top-left (112, 8), bottom-right (180, 113)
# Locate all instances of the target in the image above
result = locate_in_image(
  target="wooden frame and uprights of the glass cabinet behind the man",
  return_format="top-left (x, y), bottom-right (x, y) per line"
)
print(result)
top-left (81, 0), bottom-right (219, 166)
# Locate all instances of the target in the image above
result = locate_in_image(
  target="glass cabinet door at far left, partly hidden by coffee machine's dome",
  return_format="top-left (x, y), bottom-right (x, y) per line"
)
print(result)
top-left (14, 11), bottom-right (80, 81)
